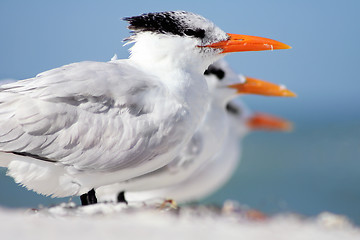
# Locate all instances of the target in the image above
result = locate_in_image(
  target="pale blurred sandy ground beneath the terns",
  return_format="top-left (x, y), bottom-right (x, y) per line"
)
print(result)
top-left (0, 202), bottom-right (360, 240)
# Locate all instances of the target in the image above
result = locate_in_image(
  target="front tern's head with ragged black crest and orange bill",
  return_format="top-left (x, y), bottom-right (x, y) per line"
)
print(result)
top-left (124, 11), bottom-right (289, 71)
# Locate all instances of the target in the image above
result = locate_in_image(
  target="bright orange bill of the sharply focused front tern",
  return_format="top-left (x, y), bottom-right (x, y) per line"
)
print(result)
top-left (205, 33), bottom-right (291, 53)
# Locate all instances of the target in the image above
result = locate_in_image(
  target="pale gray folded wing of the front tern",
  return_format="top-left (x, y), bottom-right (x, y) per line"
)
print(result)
top-left (0, 62), bottom-right (179, 171)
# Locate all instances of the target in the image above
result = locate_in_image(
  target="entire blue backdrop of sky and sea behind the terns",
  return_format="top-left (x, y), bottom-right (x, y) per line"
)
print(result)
top-left (0, 0), bottom-right (360, 223)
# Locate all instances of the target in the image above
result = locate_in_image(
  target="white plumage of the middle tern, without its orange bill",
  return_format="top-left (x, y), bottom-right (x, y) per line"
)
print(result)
top-left (97, 61), bottom-right (245, 199)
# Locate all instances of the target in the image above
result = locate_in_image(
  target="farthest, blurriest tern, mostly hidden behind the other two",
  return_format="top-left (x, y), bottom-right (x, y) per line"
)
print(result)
top-left (122, 100), bottom-right (292, 203)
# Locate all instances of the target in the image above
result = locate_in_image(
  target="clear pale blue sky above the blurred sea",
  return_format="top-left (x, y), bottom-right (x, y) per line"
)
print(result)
top-left (0, 0), bottom-right (360, 124)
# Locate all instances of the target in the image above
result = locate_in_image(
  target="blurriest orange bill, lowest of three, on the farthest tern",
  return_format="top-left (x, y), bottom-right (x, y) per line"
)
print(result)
top-left (247, 113), bottom-right (293, 131)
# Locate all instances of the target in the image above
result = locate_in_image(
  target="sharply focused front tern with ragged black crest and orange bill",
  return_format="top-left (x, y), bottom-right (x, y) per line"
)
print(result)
top-left (0, 11), bottom-right (290, 205)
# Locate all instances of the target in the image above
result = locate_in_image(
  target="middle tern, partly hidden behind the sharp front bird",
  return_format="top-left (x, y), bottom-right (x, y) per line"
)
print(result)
top-left (97, 60), bottom-right (295, 202)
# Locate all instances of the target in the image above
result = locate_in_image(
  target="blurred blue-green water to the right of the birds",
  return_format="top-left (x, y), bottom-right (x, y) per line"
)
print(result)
top-left (205, 119), bottom-right (360, 224)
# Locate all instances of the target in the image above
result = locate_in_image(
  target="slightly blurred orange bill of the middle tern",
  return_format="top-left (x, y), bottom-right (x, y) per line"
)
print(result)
top-left (227, 77), bottom-right (296, 97)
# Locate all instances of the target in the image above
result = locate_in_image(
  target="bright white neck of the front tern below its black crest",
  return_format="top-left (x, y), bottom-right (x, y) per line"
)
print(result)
top-left (130, 32), bottom-right (220, 124)
